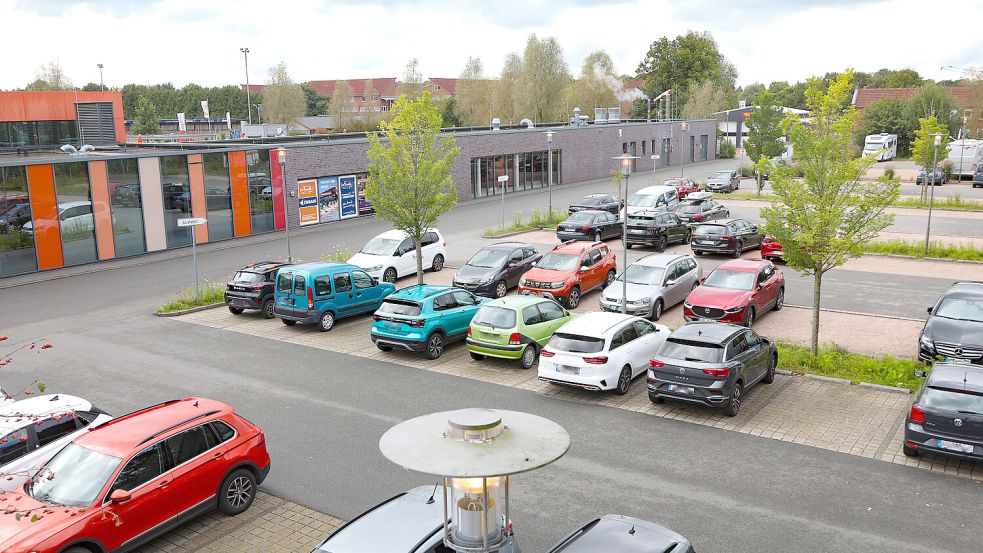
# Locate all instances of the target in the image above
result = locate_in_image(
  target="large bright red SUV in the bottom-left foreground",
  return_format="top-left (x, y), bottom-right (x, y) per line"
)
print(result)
top-left (0, 398), bottom-right (270, 553)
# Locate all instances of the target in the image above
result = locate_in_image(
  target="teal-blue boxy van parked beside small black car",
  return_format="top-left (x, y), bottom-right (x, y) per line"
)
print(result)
top-left (273, 263), bottom-right (396, 332)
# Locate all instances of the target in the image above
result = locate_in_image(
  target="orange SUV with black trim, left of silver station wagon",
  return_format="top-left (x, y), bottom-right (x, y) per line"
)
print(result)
top-left (519, 240), bottom-right (618, 309)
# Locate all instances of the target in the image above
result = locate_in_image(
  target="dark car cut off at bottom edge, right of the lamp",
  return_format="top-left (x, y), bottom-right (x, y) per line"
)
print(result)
top-left (547, 515), bottom-right (694, 553)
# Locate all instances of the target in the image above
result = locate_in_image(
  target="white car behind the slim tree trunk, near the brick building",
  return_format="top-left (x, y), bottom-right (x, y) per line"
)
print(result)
top-left (348, 228), bottom-right (447, 282)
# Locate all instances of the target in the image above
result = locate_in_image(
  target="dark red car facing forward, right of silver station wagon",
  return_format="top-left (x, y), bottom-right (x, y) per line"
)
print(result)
top-left (683, 259), bottom-right (785, 327)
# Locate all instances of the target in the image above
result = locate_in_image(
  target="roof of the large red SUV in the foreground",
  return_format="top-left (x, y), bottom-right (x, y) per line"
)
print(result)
top-left (75, 397), bottom-right (232, 457)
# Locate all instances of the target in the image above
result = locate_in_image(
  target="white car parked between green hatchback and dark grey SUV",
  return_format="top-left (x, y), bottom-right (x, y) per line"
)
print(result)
top-left (539, 312), bottom-right (670, 395)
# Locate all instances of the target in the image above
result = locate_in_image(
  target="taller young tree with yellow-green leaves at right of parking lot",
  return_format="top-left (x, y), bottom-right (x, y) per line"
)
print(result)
top-left (761, 71), bottom-right (900, 355)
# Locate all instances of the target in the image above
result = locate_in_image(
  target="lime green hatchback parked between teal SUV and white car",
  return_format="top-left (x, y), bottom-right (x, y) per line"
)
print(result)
top-left (466, 295), bottom-right (576, 369)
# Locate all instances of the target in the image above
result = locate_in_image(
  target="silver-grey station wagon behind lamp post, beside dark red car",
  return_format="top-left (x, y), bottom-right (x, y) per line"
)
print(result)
top-left (601, 253), bottom-right (703, 321)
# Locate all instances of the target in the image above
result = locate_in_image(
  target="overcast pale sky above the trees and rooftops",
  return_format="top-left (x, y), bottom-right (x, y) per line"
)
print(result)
top-left (0, 0), bottom-right (983, 89)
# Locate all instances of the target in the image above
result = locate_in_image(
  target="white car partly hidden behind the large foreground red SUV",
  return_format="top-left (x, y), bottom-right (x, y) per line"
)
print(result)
top-left (0, 394), bottom-right (113, 490)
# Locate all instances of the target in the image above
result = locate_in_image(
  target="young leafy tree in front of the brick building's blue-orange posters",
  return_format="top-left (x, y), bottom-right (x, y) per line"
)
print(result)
top-left (365, 91), bottom-right (461, 284)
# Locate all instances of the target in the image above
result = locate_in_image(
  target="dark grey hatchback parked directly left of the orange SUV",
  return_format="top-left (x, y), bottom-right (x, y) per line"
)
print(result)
top-left (453, 242), bottom-right (543, 298)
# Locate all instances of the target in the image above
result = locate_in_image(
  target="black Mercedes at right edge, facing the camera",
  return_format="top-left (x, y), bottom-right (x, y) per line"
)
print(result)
top-left (918, 282), bottom-right (983, 365)
